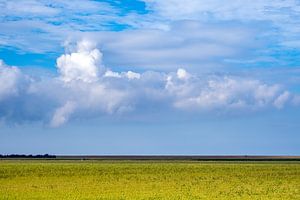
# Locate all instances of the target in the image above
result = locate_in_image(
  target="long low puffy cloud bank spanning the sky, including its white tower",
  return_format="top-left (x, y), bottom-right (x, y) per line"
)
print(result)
top-left (0, 40), bottom-right (296, 127)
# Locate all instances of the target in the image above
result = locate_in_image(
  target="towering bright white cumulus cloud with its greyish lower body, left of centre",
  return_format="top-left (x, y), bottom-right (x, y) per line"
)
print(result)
top-left (50, 40), bottom-right (135, 127)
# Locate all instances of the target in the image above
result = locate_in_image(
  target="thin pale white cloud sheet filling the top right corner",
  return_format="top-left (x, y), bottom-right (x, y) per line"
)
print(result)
top-left (144, 0), bottom-right (300, 52)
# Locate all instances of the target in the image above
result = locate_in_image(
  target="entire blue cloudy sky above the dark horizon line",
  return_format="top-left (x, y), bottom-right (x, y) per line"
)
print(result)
top-left (0, 0), bottom-right (300, 155)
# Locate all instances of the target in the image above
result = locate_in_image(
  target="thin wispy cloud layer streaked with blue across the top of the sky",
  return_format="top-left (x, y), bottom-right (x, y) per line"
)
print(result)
top-left (0, 0), bottom-right (300, 69)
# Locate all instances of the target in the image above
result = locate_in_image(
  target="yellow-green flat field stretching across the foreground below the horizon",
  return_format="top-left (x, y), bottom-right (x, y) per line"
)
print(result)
top-left (0, 160), bottom-right (300, 200)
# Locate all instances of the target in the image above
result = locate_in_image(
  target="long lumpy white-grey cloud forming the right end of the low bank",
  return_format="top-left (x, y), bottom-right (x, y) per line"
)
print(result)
top-left (166, 73), bottom-right (290, 112)
